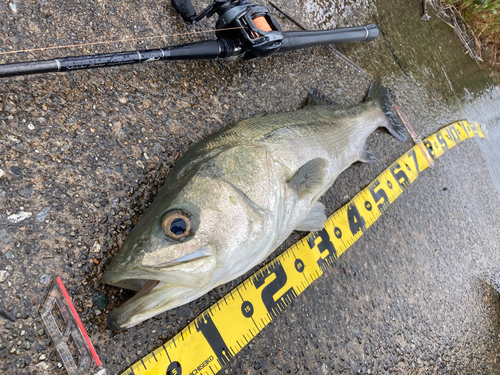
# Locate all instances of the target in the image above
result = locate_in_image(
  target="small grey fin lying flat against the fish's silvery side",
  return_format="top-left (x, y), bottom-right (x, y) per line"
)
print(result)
top-left (288, 158), bottom-right (328, 199)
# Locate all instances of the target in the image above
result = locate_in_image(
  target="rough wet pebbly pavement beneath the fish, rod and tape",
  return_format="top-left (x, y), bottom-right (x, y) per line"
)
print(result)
top-left (0, 0), bottom-right (500, 374)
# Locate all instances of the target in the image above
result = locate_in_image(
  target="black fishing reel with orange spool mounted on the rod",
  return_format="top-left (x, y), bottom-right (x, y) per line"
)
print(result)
top-left (172, 0), bottom-right (283, 60)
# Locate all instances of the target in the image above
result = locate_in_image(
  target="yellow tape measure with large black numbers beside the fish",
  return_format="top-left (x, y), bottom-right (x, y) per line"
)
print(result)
top-left (122, 121), bottom-right (485, 375)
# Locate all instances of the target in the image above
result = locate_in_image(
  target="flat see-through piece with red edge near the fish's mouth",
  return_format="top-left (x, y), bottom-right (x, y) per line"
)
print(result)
top-left (40, 277), bottom-right (106, 375)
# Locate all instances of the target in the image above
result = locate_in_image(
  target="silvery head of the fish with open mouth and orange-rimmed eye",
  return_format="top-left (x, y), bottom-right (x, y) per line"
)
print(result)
top-left (103, 171), bottom-right (265, 330)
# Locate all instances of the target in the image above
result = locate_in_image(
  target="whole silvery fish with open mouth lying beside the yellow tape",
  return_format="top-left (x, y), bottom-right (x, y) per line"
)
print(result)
top-left (103, 80), bottom-right (408, 331)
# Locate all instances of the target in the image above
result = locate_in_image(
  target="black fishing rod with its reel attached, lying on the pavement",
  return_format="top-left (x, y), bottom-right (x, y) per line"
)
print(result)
top-left (0, 0), bottom-right (378, 78)
